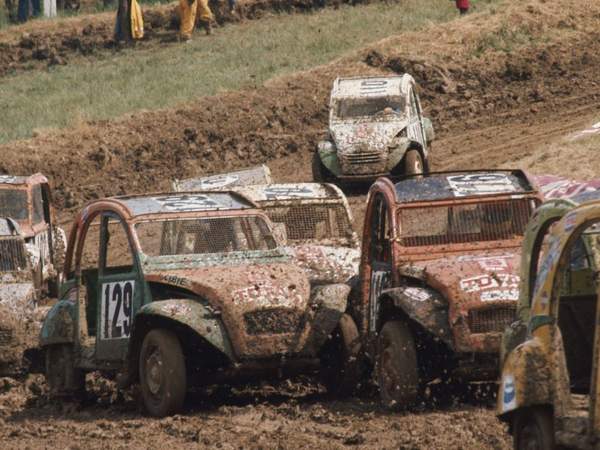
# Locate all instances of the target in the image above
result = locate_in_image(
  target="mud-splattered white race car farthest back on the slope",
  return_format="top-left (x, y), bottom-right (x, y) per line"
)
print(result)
top-left (312, 74), bottom-right (434, 182)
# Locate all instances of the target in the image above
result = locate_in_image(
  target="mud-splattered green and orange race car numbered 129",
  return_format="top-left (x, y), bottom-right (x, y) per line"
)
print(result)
top-left (41, 191), bottom-right (358, 416)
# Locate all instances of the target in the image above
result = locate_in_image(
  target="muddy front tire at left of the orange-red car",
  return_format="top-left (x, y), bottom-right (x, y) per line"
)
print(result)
top-left (375, 320), bottom-right (419, 410)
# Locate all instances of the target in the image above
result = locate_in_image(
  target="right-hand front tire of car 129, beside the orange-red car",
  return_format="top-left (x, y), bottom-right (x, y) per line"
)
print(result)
top-left (321, 314), bottom-right (362, 396)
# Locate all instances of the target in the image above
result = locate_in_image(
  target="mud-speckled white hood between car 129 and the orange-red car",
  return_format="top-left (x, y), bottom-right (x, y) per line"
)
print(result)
top-left (290, 244), bottom-right (360, 284)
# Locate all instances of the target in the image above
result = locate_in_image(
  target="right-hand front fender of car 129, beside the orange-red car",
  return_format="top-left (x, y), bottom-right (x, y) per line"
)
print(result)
top-left (305, 283), bottom-right (350, 354)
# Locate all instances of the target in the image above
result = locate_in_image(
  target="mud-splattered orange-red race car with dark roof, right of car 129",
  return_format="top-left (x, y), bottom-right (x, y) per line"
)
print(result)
top-left (352, 171), bottom-right (540, 408)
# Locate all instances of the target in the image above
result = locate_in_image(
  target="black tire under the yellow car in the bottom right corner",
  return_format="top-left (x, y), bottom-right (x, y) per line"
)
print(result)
top-left (513, 406), bottom-right (556, 450)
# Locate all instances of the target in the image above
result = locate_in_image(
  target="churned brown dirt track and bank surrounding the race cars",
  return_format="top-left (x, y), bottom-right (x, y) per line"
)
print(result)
top-left (0, 0), bottom-right (600, 448)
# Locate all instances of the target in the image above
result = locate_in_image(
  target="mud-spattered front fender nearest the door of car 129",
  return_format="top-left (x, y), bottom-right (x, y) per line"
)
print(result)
top-left (134, 299), bottom-right (235, 360)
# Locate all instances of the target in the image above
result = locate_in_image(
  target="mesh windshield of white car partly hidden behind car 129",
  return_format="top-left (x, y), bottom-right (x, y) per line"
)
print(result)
top-left (263, 204), bottom-right (352, 245)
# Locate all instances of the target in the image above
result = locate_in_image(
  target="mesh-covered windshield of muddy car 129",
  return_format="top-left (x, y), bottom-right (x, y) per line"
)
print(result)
top-left (135, 216), bottom-right (277, 256)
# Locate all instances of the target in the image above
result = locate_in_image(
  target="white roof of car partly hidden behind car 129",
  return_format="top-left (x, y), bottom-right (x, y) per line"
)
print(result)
top-left (234, 183), bottom-right (343, 203)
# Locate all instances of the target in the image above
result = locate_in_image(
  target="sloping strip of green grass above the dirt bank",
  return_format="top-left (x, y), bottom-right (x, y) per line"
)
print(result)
top-left (0, 0), bottom-right (487, 142)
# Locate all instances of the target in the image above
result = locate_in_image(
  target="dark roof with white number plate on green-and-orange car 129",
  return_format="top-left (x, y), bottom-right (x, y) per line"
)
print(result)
top-left (111, 191), bottom-right (256, 217)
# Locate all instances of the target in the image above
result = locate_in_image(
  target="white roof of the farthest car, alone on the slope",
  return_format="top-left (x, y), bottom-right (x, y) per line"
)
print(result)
top-left (331, 74), bottom-right (413, 98)
